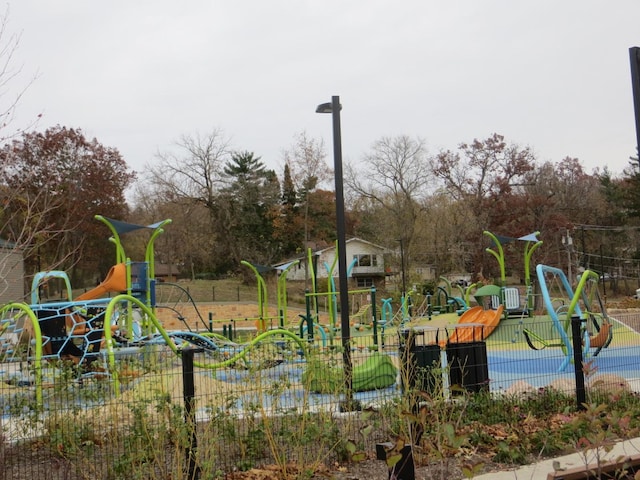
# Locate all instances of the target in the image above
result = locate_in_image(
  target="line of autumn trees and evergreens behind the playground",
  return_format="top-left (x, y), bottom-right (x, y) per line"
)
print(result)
top-left (0, 122), bottom-right (640, 298)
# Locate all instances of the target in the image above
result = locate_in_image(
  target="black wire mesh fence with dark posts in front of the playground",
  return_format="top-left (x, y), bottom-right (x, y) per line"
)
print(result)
top-left (0, 314), bottom-right (640, 480)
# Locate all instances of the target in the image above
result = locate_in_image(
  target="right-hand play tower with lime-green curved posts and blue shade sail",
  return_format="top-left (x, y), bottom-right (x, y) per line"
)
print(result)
top-left (483, 231), bottom-right (543, 317)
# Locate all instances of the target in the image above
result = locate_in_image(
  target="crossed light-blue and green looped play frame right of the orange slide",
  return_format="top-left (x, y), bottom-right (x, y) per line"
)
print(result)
top-left (523, 265), bottom-right (613, 372)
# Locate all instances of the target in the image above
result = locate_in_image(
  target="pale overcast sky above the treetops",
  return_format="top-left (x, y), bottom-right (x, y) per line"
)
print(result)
top-left (9, 0), bottom-right (640, 175)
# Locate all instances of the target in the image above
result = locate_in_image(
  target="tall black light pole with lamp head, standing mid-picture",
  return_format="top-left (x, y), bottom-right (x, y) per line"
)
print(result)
top-left (316, 95), bottom-right (353, 410)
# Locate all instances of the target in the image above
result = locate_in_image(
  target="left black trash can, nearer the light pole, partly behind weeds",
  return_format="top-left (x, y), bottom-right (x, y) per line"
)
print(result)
top-left (399, 327), bottom-right (441, 393)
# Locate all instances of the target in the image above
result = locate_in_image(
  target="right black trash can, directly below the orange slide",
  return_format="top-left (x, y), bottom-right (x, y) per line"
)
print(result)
top-left (446, 324), bottom-right (489, 393)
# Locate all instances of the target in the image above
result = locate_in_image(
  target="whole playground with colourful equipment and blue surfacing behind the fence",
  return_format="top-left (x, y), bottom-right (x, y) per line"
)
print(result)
top-left (0, 217), bottom-right (640, 478)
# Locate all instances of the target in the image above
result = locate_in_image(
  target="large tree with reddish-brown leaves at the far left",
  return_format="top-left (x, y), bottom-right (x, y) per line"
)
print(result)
top-left (0, 126), bottom-right (135, 281)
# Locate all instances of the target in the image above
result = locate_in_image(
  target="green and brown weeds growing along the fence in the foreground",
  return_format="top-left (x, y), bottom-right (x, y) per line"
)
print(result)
top-left (0, 340), bottom-right (640, 480)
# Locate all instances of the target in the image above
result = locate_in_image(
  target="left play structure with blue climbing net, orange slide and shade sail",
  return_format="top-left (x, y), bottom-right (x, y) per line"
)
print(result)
top-left (0, 215), bottom-right (171, 402)
